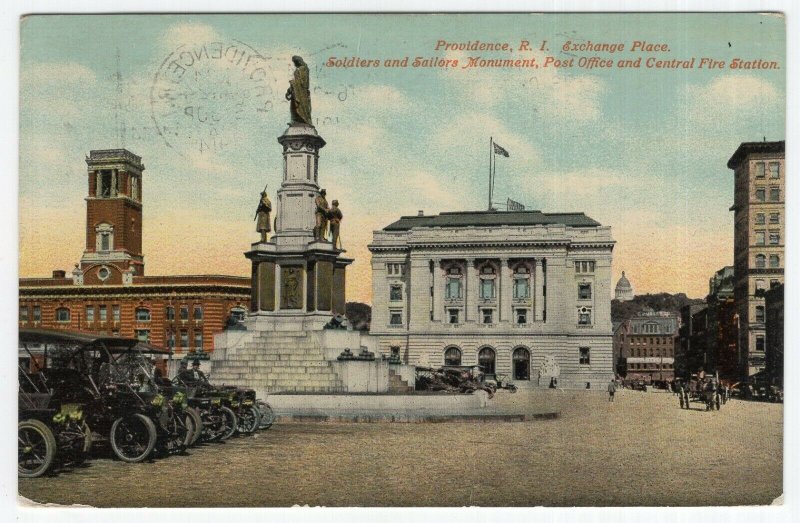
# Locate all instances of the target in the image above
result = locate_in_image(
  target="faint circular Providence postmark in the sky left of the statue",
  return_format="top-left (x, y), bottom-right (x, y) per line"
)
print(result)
top-left (150, 40), bottom-right (278, 157)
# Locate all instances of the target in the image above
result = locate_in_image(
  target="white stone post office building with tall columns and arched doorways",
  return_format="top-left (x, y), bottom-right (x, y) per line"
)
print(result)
top-left (369, 211), bottom-right (614, 388)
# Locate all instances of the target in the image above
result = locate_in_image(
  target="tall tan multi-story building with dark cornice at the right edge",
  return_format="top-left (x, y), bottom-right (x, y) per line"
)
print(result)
top-left (728, 141), bottom-right (786, 379)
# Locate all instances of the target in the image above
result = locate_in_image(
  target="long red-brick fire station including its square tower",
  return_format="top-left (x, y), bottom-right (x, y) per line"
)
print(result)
top-left (19, 149), bottom-right (250, 353)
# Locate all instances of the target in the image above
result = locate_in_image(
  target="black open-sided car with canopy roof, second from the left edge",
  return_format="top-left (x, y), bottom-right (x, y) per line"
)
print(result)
top-left (19, 329), bottom-right (195, 463)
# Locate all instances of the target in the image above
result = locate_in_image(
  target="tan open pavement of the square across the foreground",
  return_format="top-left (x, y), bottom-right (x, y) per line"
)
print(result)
top-left (19, 390), bottom-right (783, 507)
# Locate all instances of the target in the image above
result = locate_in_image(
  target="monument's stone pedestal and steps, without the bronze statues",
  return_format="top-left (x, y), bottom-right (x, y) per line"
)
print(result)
top-left (211, 123), bottom-right (360, 394)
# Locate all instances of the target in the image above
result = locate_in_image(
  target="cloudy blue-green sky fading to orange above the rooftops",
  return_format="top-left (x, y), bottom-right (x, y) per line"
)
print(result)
top-left (19, 13), bottom-right (786, 303)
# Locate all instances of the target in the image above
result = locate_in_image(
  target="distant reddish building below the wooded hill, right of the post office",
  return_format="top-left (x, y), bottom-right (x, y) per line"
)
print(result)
top-left (615, 310), bottom-right (678, 383)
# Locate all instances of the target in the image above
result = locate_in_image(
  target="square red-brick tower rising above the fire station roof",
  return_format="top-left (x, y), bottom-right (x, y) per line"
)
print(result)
top-left (72, 149), bottom-right (144, 285)
